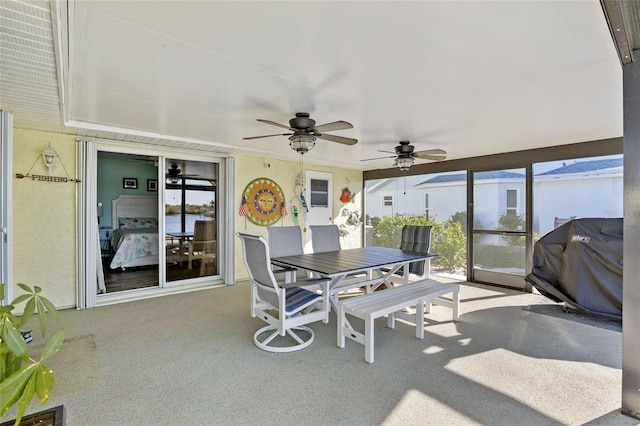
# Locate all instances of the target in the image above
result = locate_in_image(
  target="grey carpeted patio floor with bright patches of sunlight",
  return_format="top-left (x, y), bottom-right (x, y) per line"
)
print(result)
top-left (2, 282), bottom-right (639, 426)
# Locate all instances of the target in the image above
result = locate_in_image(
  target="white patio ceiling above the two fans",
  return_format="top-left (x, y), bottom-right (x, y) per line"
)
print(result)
top-left (0, 0), bottom-right (623, 170)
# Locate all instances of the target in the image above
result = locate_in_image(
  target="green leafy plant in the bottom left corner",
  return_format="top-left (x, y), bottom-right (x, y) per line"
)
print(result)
top-left (0, 284), bottom-right (64, 425)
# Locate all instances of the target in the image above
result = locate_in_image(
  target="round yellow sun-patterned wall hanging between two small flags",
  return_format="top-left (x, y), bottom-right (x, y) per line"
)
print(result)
top-left (243, 178), bottom-right (284, 226)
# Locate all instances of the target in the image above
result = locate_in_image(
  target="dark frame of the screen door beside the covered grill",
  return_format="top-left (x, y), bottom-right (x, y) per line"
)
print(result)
top-left (467, 163), bottom-right (533, 292)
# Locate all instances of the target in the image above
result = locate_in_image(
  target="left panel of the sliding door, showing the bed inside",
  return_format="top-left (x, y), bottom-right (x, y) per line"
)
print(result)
top-left (96, 151), bottom-right (163, 294)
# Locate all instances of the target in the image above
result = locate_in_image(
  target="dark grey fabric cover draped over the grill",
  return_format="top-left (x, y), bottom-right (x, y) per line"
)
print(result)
top-left (525, 218), bottom-right (622, 319)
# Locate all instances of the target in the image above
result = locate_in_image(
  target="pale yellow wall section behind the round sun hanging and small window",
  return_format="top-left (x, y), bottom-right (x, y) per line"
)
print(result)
top-left (233, 157), bottom-right (363, 281)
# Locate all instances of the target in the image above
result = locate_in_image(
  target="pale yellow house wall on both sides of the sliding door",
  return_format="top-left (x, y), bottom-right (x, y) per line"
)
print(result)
top-left (7, 129), bottom-right (362, 308)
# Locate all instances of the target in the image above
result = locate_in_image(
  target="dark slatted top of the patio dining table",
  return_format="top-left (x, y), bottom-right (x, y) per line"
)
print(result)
top-left (271, 247), bottom-right (436, 276)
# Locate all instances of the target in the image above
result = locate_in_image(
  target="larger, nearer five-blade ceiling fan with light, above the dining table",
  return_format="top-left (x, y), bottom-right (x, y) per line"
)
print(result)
top-left (242, 112), bottom-right (358, 154)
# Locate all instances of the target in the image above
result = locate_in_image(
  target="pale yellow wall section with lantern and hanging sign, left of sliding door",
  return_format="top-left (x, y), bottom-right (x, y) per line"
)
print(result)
top-left (12, 129), bottom-right (77, 308)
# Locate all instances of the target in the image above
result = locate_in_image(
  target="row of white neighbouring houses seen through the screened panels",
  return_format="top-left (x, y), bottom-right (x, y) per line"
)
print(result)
top-left (365, 156), bottom-right (623, 235)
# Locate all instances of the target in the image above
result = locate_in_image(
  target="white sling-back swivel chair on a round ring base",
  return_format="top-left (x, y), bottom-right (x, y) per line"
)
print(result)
top-left (236, 233), bottom-right (330, 352)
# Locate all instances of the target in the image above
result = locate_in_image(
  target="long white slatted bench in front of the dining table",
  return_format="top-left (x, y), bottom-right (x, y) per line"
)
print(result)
top-left (338, 279), bottom-right (460, 363)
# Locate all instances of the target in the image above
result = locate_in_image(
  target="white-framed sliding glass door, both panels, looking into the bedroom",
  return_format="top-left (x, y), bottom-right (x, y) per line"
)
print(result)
top-left (88, 145), bottom-right (222, 306)
